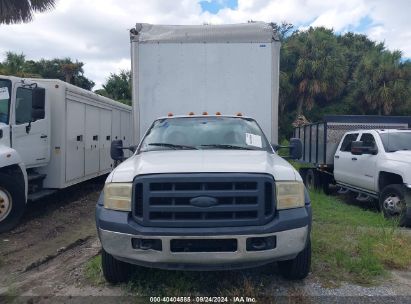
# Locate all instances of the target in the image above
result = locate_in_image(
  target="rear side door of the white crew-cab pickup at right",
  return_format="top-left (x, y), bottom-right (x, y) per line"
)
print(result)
top-left (334, 133), bottom-right (359, 185)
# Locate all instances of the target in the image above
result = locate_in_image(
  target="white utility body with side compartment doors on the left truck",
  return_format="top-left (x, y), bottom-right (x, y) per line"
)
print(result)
top-left (32, 79), bottom-right (131, 188)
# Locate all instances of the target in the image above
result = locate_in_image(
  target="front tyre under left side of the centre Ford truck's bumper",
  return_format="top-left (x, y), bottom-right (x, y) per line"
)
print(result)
top-left (101, 249), bottom-right (133, 284)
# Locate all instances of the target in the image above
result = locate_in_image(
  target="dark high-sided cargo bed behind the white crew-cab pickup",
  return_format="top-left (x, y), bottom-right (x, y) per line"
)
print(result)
top-left (294, 115), bottom-right (411, 165)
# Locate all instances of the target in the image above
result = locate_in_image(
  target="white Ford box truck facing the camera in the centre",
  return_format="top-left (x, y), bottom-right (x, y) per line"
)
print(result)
top-left (96, 23), bottom-right (311, 282)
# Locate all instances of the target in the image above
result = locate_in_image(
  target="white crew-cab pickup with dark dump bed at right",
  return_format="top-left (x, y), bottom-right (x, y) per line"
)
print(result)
top-left (294, 115), bottom-right (411, 225)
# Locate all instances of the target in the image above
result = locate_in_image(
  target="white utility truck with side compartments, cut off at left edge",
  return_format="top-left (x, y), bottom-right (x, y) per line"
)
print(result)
top-left (0, 75), bottom-right (132, 232)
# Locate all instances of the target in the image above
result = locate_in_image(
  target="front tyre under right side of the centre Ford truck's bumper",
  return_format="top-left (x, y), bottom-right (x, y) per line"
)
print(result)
top-left (278, 240), bottom-right (311, 280)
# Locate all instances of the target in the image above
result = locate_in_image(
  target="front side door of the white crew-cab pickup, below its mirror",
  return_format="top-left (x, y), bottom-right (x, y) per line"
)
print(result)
top-left (356, 133), bottom-right (378, 191)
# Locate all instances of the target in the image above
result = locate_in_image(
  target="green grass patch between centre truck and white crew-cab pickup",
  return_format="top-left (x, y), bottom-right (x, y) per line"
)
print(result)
top-left (311, 192), bottom-right (411, 284)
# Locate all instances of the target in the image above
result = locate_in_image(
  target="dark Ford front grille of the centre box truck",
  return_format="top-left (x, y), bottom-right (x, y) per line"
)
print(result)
top-left (133, 173), bottom-right (275, 227)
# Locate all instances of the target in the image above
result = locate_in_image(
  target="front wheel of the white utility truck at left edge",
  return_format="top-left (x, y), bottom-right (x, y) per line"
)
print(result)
top-left (0, 173), bottom-right (26, 233)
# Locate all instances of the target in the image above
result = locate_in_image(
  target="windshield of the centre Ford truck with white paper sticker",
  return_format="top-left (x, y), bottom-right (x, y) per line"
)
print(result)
top-left (139, 117), bottom-right (272, 152)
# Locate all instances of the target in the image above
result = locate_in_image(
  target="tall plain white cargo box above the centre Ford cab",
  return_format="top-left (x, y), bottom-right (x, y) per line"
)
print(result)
top-left (131, 23), bottom-right (280, 143)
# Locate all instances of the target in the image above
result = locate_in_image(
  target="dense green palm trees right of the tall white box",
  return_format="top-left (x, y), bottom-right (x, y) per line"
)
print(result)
top-left (274, 24), bottom-right (411, 138)
